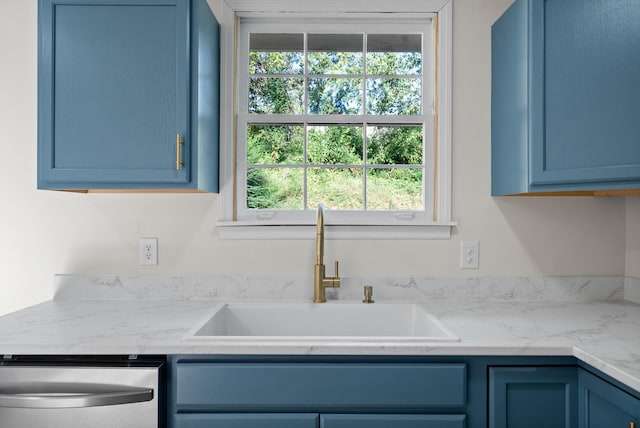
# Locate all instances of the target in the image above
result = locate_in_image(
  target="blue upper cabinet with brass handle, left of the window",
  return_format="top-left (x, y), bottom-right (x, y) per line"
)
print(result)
top-left (38, 0), bottom-right (219, 192)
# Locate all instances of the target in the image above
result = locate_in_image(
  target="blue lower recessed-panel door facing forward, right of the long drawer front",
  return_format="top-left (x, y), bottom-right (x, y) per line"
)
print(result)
top-left (489, 367), bottom-right (578, 428)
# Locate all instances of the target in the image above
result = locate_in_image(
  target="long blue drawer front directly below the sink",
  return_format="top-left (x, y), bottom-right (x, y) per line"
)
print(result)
top-left (176, 363), bottom-right (466, 412)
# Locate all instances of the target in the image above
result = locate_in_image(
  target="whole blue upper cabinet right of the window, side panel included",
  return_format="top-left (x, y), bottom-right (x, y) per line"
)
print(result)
top-left (491, 0), bottom-right (640, 195)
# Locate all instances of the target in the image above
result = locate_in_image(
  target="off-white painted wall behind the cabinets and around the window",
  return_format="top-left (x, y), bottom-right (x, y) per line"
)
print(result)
top-left (0, 0), bottom-right (640, 313)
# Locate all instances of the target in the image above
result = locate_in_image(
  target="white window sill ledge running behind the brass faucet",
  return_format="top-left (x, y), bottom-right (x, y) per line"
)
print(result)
top-left (216, 221), bottom-right (457, 240)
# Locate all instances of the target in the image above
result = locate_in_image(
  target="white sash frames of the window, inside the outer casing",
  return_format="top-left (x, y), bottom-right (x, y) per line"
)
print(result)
top-left (236, 19), bottom-right (435, 225)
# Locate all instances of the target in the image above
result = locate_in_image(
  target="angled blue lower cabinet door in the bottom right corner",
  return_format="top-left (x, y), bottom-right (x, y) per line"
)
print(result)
top-left (578, 370), bottom-right (640, 428)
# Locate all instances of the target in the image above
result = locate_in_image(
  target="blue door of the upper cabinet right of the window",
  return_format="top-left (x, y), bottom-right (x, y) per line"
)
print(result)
top-left (530, 0), bottom-right (640, 188)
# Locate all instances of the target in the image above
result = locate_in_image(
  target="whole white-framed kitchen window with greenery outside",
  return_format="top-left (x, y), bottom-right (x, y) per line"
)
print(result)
top-left (221, 2), bottom-right (453, 238)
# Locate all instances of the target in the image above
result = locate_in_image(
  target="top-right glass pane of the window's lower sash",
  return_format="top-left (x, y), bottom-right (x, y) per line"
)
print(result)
top-left (367, 126), bottom-right (423, 165)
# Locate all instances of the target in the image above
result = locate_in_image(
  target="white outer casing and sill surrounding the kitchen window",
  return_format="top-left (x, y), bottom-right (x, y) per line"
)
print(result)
top-left (217, 0), bottom-right (456, 239)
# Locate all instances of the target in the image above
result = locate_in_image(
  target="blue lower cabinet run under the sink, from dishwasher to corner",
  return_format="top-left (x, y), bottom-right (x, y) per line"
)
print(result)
top-left (168, 355), bottom-right (592, 428)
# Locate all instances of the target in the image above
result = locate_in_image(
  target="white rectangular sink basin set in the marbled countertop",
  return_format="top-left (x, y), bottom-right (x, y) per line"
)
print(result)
top-left (188, 303), bottom-right (459, 342)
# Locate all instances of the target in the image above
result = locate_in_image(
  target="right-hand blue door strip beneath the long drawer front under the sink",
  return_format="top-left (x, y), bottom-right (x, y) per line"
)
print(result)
top-left (320, 415), bottom-right (466, 428)
